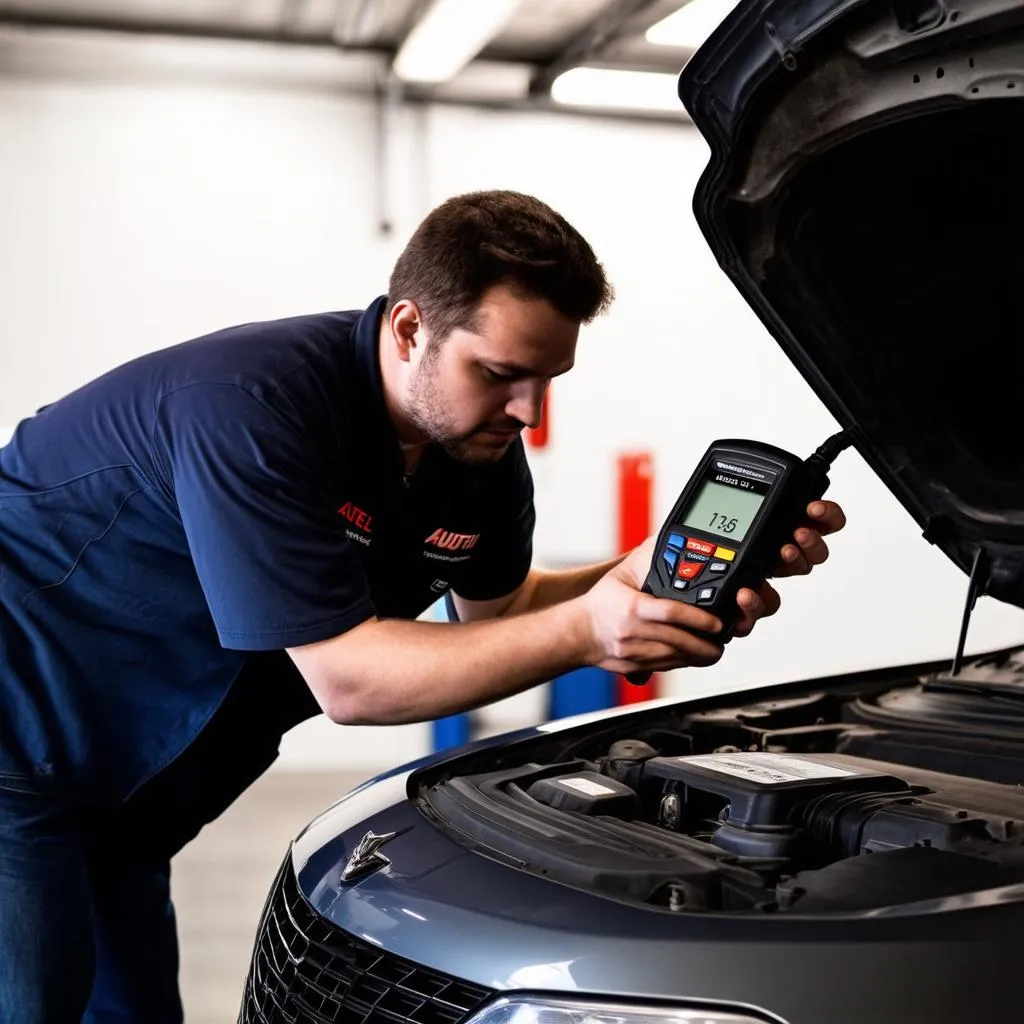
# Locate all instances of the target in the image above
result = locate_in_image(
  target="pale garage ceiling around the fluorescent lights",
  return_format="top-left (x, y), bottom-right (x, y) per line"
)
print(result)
top-left (0, 0), bottom-right (689, 111)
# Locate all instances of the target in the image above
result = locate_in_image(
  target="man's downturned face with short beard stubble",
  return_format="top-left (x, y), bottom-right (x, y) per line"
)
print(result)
top-left (404, 286), bottom-right (580, 463)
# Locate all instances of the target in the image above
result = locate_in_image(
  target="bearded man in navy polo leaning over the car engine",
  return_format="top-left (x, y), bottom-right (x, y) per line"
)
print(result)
top-left (0, 193), bottom-right (843, 1024)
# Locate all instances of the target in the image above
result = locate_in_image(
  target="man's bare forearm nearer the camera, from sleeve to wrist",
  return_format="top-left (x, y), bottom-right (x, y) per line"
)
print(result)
top-left (291, 603), bottom-right (592, 725)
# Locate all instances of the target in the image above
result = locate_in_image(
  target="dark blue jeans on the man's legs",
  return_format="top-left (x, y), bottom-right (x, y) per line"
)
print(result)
top-left (0, 778), bottom-right (181, 1024)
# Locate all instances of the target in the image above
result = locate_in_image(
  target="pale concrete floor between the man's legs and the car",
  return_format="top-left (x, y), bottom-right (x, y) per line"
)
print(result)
top-left (171, 771), bottom-right (370, 1024)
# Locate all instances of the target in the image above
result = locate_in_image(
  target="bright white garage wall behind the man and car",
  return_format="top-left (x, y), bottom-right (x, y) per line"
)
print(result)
top-left (0, 28), bottom-right (1024, 770)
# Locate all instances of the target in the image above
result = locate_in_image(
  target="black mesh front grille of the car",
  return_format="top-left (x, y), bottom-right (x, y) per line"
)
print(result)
top-left (239, 856), bottom-right (494, 1024)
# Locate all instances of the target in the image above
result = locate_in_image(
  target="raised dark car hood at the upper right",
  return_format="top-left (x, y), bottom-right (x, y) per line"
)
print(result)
top-left (679, 0), bottom-right (1024, 606)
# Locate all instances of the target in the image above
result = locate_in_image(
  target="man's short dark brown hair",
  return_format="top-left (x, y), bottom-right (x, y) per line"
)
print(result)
top-left (387, 191), bottom-right (613, 340)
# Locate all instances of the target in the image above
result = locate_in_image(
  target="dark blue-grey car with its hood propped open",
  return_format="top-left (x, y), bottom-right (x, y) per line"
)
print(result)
top-left (240, 0), bottom-right (1024, 1024)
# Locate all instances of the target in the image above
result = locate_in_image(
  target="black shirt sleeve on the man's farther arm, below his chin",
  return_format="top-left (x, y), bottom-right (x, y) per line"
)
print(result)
top-left (455, 440), bottom-right (537, 601)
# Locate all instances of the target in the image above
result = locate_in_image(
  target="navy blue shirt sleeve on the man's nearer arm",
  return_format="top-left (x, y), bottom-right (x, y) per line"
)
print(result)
top-left (154, 383), bottom-right (375, 650)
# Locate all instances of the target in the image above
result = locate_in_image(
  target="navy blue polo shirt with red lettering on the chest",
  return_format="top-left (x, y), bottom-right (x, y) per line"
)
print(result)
top-left (0, 298), bottom-right (534, 799)
